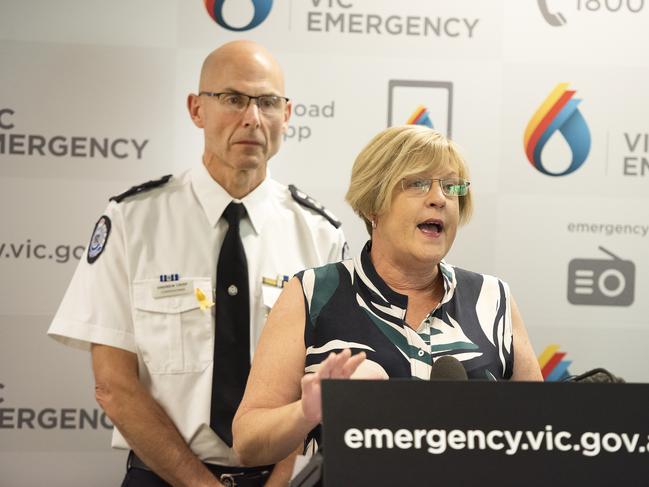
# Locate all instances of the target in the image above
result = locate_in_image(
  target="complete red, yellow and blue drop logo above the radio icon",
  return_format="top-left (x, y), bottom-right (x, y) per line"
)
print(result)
top-left (524, 83), bottom-right (590, 176)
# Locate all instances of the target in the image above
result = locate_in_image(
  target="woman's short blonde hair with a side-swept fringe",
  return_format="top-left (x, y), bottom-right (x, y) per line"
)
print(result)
top-left (345, 125), bottom-right (473, 235)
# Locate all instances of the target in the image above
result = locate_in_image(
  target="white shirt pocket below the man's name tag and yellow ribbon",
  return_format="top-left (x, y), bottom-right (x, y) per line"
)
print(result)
top-left (133, 278), bottom-right (214, 374)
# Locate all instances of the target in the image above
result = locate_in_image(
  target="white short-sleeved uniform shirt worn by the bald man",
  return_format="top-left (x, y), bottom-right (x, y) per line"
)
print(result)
top-left (48, 165), bottom-right (345, 465)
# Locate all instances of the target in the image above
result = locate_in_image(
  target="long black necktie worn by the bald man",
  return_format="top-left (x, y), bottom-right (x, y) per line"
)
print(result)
top-left (210, 202), bottom-right (250, 446)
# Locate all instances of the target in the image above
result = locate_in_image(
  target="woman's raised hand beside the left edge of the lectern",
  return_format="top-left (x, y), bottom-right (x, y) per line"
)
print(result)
top-left (302, 348), bottom-right (365, 426)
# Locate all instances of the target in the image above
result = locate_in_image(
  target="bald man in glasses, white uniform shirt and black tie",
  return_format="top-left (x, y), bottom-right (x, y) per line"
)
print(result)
top-left (48, 41), bottom-right (345, 486)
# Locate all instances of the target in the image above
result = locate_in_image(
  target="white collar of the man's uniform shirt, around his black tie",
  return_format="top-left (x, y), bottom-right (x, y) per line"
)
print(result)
top-left (191, 164), bottom-right (271, 234)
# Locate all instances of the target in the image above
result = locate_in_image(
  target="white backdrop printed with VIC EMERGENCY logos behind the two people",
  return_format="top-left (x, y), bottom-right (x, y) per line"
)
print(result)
top-left (0, 0), bottom-right (649, 487)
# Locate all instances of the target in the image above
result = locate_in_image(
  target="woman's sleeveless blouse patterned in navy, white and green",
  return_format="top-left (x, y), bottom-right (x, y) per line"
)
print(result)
top-left (297, 241), bottom-right (514, 380)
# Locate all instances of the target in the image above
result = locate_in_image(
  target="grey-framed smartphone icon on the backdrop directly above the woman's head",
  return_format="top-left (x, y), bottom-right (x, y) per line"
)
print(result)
top-left (388, 79), bottom-right (453, 138)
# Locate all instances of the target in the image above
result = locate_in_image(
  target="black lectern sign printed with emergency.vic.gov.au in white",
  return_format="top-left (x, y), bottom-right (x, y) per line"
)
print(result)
top-left (322, 380), bottom-right (649, 487)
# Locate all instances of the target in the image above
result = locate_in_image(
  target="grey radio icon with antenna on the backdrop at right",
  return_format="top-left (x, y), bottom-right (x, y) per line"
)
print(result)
top-left (568, 250), bottom-right (635, 306)
